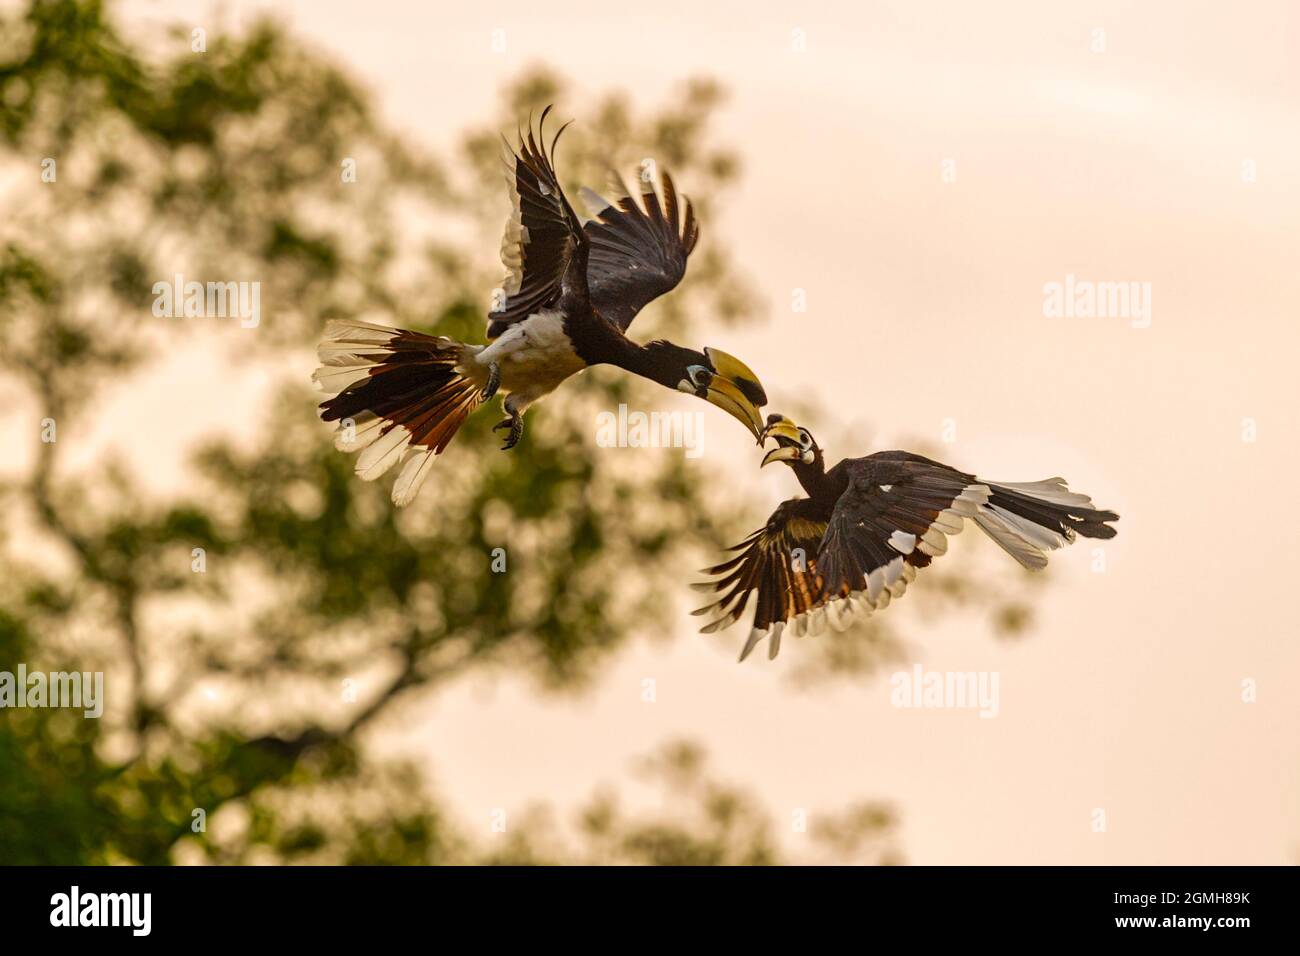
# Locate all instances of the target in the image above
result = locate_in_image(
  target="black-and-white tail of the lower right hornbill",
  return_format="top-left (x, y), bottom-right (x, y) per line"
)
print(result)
top-left (975, 477), bottom-right (1119, 570)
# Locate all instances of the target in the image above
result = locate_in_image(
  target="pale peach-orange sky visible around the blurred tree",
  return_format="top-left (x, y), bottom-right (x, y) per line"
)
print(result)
top-left (61, 0), bottom-right (1300, 864)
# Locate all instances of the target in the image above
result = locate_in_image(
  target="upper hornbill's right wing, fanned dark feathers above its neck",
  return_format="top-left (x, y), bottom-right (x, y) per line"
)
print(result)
top-left (581, 172), bottom-right (699, 332)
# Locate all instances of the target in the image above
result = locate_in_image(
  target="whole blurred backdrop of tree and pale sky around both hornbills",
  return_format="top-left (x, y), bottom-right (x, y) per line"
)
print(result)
top-left (0, 0), bottom-right (1300, 864)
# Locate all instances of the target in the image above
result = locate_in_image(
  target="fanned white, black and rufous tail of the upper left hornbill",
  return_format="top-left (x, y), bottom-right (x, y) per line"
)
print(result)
top-left (312, 321), bottom-right (482, 506)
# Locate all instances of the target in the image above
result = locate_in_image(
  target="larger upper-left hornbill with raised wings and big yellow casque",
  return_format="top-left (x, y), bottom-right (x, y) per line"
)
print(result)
top-left (313, 107), bottom-right (767, 505)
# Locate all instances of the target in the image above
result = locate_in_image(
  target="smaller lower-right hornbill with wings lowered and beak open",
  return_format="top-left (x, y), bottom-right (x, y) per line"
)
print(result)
top-left (694, 415), bottom-right (1119, 661)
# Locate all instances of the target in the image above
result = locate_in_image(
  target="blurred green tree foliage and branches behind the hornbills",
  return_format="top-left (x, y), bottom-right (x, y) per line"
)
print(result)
top-left (0, 0), bottom-right (1029, 864)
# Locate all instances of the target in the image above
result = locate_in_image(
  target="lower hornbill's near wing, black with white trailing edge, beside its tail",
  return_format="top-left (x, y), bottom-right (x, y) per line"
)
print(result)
top-left (818, 451), bottom-right (989, 611)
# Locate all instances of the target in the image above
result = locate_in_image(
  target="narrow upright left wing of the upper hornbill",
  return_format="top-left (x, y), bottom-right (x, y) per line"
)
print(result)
top-left (488, 107), bottom-right (586, 338)
